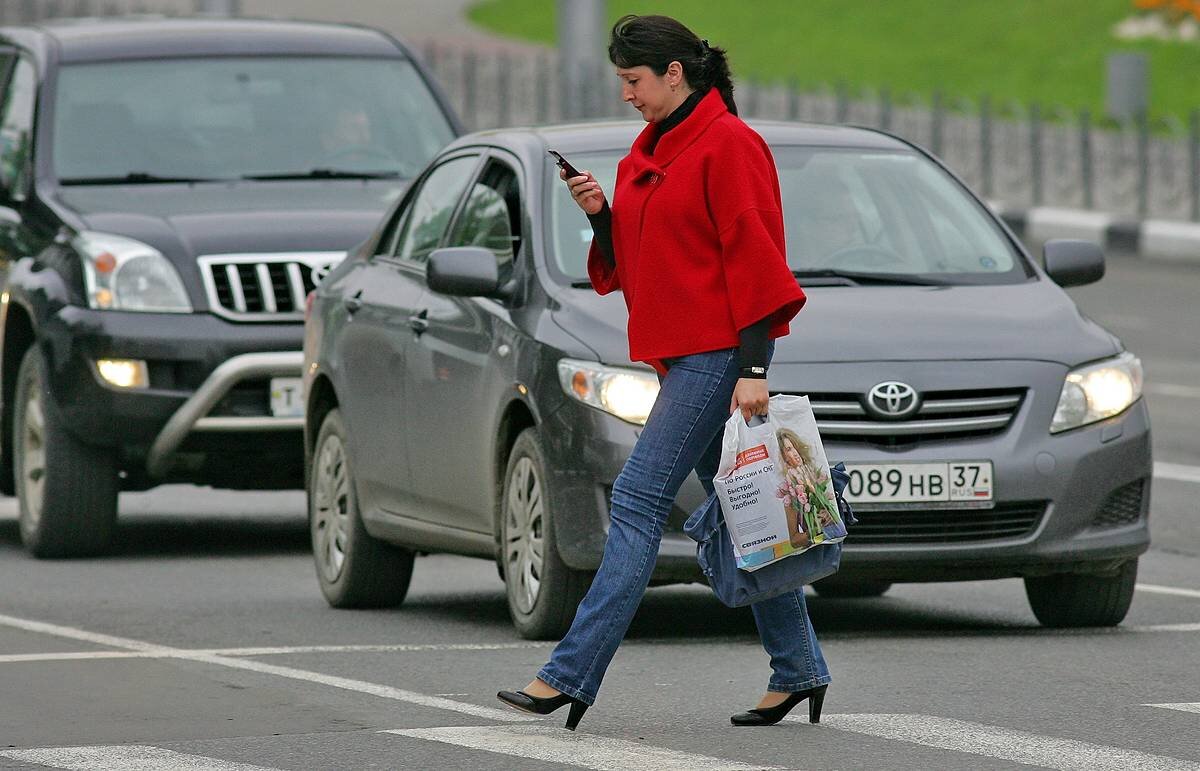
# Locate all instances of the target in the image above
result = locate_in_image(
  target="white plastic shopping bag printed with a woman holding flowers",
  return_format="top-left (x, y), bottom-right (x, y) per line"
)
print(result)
top-left (713, 395), bottom-right (846, 570)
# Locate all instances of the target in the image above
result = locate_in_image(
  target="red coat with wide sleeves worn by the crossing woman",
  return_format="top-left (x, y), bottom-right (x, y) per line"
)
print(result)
top-left (588, 89), bottom-right (805, 372)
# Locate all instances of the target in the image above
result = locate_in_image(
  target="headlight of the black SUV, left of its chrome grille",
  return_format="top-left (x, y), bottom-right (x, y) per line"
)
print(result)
top-left (72, 231), bottom-right (192, 313)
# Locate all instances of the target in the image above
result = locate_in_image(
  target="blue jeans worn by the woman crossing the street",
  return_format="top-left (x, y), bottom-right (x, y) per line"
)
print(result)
top-left (538, 341), bottom-right (829, 704)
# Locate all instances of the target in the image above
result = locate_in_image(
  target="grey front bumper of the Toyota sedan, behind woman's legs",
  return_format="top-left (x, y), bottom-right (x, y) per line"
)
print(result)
top-left (542, 384), bottom-right (1152, 581)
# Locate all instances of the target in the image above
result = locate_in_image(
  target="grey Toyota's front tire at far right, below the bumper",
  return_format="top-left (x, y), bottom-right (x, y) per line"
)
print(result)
top-left (1025, 560), bottom-right (1138, 628)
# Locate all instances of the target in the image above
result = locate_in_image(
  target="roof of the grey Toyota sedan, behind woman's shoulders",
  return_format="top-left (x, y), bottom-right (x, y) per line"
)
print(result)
top-left (451, 120), bottom-right (912, 160)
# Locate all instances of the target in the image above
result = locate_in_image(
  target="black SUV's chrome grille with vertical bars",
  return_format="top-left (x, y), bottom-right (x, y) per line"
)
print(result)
top-left (199, 252), bottom-right (344, 321)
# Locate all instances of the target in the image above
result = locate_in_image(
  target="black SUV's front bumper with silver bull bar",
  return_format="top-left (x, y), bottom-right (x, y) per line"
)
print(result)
top-left (38, 306), bottom-right (304, 489)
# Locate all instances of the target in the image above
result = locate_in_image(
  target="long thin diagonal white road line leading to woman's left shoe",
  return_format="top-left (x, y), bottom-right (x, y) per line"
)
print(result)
top-left (0, 615), bottom-right (536, 723)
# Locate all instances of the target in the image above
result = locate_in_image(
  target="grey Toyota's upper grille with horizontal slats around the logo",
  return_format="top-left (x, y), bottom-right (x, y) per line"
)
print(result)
top-left (782, 388), bottom-right (1025, 444)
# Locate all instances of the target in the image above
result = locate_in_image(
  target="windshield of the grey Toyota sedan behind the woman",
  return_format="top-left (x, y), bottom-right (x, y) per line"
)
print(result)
top-left (547, 147), bottom-right (1026, 285)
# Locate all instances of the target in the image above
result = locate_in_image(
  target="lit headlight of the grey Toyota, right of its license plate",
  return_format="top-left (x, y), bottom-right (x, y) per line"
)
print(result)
top-left (1050, 352), bottom-right (1141, 434)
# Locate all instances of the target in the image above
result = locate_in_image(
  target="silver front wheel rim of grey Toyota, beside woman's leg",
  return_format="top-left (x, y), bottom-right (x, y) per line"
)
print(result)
top-left (504, 458), bottom-right (545, 614)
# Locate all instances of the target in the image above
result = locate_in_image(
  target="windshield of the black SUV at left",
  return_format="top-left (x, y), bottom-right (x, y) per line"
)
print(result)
top-left (53, 56), bottom-right (452, 184)
